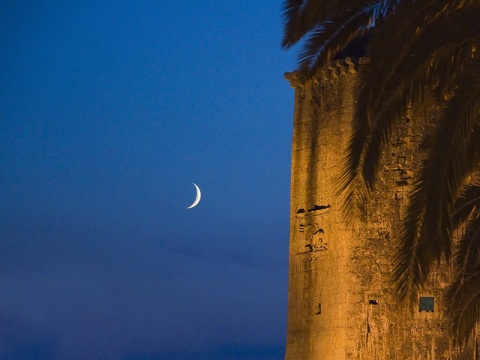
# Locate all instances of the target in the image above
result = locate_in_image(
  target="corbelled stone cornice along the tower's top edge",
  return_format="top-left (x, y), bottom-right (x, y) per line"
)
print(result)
top-left (284, 57), bottom-right (367, 89)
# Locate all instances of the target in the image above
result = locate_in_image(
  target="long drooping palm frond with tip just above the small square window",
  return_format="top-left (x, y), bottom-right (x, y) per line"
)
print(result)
top-left (394, 73), bottom-right (480, 299)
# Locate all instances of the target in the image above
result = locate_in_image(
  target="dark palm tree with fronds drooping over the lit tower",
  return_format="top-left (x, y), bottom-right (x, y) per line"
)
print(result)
top-left (282, 0), bottom-right (480, 345)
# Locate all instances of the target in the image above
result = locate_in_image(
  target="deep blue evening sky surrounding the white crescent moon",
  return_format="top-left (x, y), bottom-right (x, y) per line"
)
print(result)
top-left (0, 0), bottom-right (295, 360)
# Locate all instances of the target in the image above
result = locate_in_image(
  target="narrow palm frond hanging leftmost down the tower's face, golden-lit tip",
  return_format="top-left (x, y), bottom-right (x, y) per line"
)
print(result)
top-left (338, 0), bottom-right (450, 211)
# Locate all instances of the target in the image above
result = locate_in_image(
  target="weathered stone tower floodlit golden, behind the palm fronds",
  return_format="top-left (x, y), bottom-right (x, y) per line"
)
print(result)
top-left (285, 58), bottom-right (478, 360)
